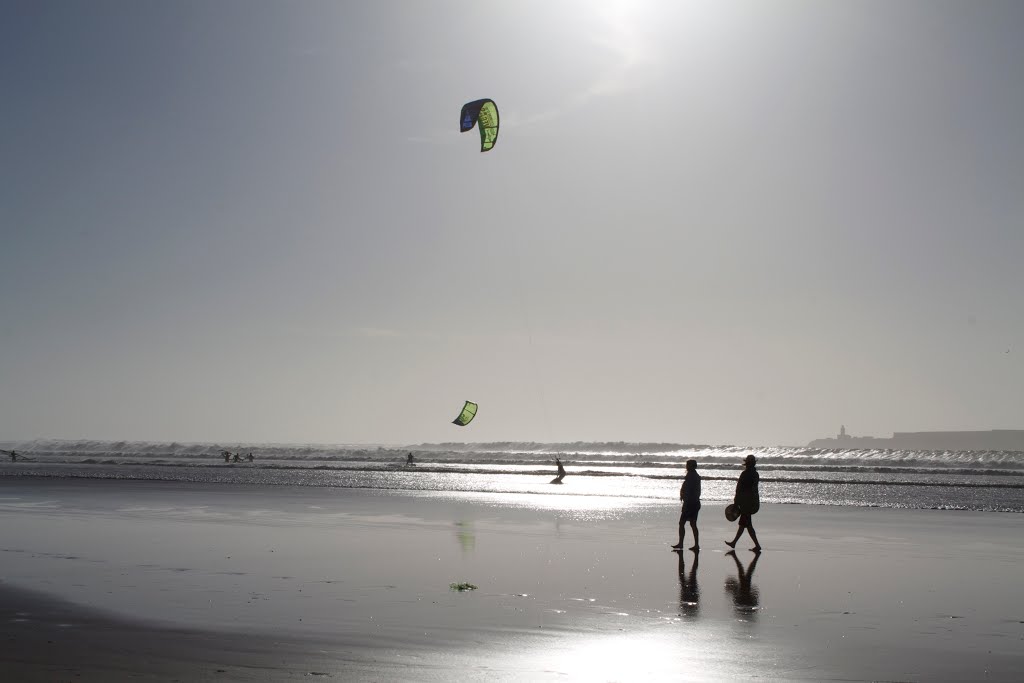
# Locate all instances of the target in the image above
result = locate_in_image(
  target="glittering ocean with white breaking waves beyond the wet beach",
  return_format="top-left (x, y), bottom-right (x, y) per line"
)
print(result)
top-left (0, 439), bottom-right (1024, 513)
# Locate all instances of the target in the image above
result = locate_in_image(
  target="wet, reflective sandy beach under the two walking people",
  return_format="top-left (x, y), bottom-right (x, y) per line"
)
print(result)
top-left (0, 477), bottom-right (1024, 681)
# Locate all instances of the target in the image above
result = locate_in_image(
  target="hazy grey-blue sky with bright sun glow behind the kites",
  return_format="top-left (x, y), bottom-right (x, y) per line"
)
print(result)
top-left (0, 0), bottom-right (1024, 445)
